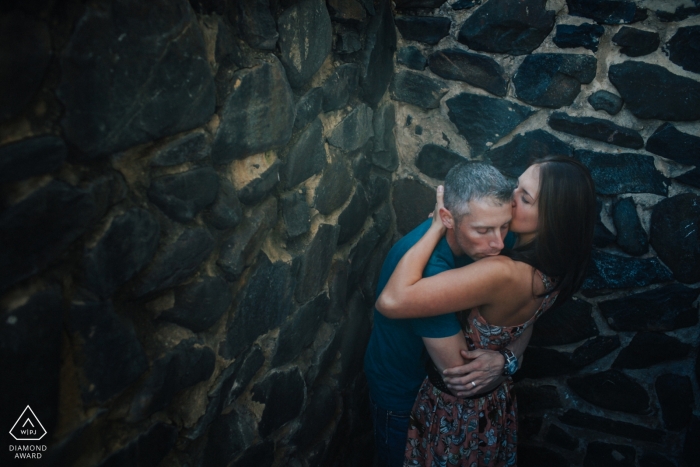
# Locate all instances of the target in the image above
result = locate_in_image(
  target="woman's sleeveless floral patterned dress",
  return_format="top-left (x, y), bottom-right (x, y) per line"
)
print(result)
top-left (404, 271), bottom-right (557, 467)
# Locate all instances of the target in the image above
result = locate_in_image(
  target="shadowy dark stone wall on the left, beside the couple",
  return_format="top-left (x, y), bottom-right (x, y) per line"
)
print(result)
top-left (0, 0), bottom-right (398, 467)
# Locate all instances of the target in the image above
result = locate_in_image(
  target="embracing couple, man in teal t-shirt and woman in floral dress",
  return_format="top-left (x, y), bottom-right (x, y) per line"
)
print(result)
top-left (365, 157), bottom-right (596, 467)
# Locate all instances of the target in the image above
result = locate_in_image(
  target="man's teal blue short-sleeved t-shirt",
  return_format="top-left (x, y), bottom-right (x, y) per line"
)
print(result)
top-left (365, 219), bottom-right (514, 412)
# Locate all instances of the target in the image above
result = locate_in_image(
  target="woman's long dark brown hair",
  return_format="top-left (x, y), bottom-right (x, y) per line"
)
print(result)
top-left (504, 156), bottom-right (596, 306)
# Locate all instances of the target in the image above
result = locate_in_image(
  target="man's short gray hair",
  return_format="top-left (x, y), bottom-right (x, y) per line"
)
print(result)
top-left (444, 162), bottom-right (513, 219)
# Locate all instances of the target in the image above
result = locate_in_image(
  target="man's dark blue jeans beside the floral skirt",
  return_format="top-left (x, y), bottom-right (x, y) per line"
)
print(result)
top-left (370, 398), bottom-right (411, 467)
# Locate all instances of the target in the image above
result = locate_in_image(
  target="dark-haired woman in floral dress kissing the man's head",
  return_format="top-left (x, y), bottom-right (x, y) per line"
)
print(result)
top-left (377, 157), bottom-right (596, 467)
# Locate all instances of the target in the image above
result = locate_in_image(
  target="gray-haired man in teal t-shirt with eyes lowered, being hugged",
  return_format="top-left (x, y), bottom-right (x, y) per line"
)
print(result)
top-left (365, 162), bottom-right (529, 467)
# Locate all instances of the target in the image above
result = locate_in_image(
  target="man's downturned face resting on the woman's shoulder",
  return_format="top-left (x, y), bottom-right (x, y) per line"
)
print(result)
top-left (454, 199), bottom-right (512, 261)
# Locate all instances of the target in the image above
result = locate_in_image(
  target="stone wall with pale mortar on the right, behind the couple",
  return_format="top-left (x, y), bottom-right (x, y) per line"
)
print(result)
top-left (389, 0), bottom-right (700, 467)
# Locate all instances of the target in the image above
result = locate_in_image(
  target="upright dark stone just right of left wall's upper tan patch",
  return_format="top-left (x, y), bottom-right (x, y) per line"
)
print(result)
top-left (285, 118), bottom-right (326, 188)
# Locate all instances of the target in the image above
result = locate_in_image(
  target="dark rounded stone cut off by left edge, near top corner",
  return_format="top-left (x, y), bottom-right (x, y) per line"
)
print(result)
top-left (0, 11), bottom-right (52, 122)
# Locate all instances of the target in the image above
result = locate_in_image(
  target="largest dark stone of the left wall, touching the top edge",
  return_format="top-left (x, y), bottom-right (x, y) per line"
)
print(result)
top-left (56, 0), bottom-right (216, 158)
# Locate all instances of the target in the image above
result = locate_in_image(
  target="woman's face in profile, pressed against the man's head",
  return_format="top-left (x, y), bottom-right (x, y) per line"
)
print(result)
top-left (510, 165), bottom-right (540, 244)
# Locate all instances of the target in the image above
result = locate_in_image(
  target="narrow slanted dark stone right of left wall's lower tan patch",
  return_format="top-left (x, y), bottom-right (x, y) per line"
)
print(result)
top-left (294, 224), bottom-right (340, 303)
